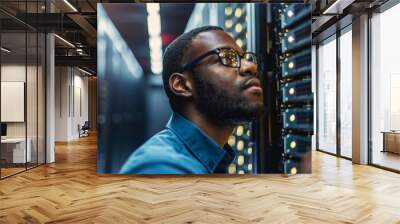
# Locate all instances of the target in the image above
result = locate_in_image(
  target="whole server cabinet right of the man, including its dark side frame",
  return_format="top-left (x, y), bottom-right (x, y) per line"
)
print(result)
top-left (256, 3), bottom-right (313, 174)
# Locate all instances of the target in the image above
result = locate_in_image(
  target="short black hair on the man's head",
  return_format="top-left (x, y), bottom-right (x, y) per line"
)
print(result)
top-left (162, 26), bottom-right (223, 109)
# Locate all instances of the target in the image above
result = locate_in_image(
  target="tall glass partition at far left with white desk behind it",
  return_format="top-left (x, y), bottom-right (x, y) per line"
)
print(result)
top-left (0, 0), bottom-right (45, 178)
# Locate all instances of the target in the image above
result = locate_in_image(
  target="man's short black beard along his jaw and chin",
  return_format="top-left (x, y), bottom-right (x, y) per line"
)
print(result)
top-left (193, 74), bottom-right (264, 126)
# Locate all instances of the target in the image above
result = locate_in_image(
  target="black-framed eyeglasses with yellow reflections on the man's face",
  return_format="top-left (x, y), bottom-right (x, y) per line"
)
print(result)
top-left (182, 48), bottom-right (257, 72)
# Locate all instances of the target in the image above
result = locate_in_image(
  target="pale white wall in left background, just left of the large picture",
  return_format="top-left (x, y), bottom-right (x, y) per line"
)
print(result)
top-left (55, 67), bottom-right (89, 141)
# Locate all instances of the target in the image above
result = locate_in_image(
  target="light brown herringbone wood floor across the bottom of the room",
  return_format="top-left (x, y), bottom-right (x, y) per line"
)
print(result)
top-left (0, 137), bottom-right (400, 224)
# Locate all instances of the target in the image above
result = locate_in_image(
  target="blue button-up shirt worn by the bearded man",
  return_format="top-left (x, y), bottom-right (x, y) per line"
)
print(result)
top-left (120, 112), bottom-right (235, 174)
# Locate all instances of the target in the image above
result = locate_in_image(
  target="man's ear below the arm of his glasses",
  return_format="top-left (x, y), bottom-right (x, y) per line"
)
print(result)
top-left (169, 72), bottom-right (193, 97)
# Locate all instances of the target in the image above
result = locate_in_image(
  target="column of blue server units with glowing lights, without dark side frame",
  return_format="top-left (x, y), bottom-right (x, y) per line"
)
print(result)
top-left (271, 4), bottom-right (313, 175)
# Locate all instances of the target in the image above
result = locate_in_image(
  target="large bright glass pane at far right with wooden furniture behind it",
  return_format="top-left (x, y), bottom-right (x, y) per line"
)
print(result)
top-left (371, 4), bottom-right (400, 170)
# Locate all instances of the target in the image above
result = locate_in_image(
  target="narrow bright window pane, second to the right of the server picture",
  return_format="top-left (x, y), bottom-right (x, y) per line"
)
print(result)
top-left (340, 30), bottom-right (353, 158)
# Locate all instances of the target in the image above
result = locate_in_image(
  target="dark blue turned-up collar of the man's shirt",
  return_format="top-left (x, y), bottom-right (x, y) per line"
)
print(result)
top-left (167, 112), bottom-right (235, 173)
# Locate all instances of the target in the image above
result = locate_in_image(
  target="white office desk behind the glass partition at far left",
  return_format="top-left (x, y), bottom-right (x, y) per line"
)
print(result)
top-left (1, 138), bottom-right (32, 163)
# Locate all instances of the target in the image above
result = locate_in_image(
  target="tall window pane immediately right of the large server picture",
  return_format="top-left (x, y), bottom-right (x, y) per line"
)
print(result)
top-left (317, 38), bottom-right (337, 154)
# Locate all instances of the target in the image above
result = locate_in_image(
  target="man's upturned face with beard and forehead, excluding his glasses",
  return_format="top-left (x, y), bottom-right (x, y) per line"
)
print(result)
top-left (186, 30), bottom-right (263, 125)
